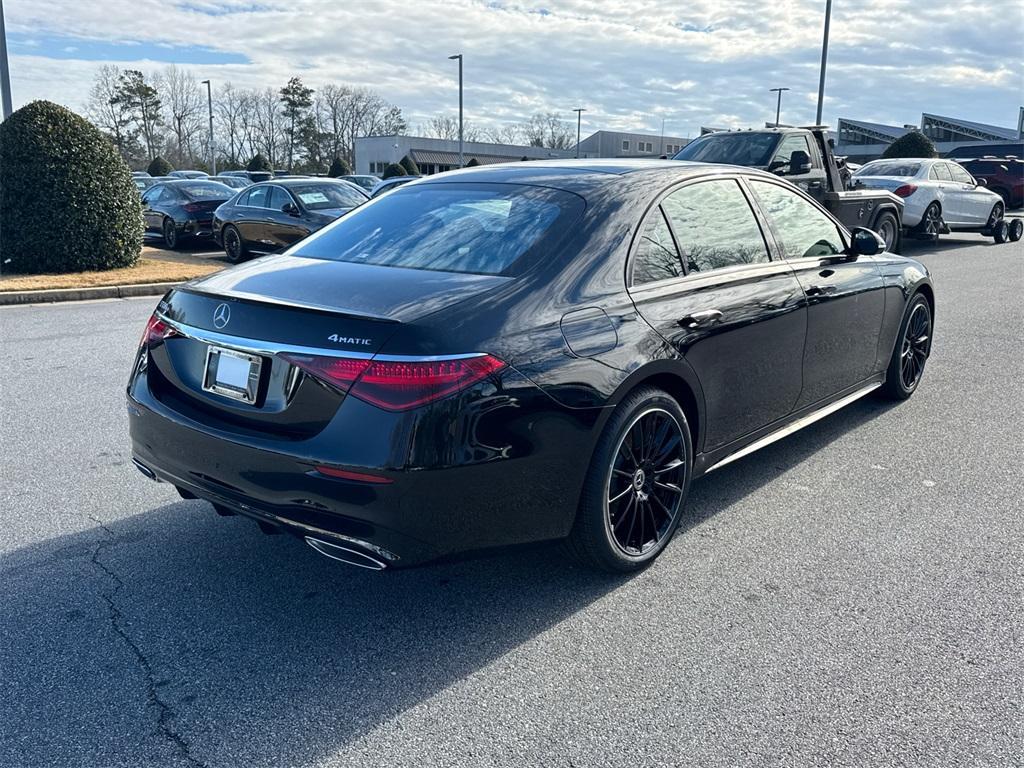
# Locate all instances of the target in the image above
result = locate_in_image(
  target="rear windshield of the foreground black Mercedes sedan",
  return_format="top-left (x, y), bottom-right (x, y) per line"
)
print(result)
top-left (290, 183), bottom-right (585, 274)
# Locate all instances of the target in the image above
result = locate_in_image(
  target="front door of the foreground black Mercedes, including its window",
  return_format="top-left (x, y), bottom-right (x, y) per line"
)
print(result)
top-left (749, 179), bottom-right (885, 410)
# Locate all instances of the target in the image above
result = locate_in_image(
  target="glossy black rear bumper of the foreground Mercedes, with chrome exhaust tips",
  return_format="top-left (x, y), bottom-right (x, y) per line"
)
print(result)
top-left (128, 364), bottom-right (593, 566)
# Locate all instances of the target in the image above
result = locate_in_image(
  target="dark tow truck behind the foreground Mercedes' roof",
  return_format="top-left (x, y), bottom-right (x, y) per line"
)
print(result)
top-left (673, 125), bottom-right (903, 253)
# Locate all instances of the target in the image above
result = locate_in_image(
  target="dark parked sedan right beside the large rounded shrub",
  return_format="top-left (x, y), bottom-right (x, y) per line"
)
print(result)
top-left (142, 179), bottom-right (236, 249)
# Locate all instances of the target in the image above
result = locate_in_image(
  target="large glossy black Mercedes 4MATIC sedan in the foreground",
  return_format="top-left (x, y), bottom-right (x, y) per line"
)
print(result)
top-left (128, 161), bottom-right (935, 570)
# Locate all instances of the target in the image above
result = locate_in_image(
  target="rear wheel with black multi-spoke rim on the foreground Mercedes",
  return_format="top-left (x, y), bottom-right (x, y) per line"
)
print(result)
top-left (566, 387), bottom-right (693, 572)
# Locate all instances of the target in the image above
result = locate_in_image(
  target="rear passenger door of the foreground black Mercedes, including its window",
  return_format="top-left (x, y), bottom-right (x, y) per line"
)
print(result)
top-left (631, 179), bottom-right (807, 452)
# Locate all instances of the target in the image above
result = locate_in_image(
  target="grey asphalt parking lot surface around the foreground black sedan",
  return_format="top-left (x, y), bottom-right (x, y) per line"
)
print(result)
top-left (0, 236), bottom-right (1024, 768)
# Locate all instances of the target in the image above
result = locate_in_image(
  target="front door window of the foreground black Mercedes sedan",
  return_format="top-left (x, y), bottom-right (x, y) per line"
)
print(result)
top-left (750, 179), bottom-right (846, 259)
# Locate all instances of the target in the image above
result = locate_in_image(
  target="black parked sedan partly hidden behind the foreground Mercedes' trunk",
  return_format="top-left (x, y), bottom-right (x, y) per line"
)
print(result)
top-left (213, 177), bottom-right (370, 264)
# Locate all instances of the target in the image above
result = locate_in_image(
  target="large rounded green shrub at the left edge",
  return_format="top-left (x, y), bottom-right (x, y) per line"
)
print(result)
top-left (0, 101), bottom-right (142, 273)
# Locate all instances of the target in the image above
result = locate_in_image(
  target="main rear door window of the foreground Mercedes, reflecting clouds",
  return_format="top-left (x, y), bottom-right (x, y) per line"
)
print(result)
top-left (662, 179), bottom-right (768, 272)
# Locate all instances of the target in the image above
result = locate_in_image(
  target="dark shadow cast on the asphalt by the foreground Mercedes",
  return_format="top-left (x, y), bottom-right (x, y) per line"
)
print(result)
top-left (0, 398), bottom-right (889, 766)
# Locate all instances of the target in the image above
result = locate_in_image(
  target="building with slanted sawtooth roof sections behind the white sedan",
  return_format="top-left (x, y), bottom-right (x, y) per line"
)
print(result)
top-left (836, 113), bottom-right (1021, 163)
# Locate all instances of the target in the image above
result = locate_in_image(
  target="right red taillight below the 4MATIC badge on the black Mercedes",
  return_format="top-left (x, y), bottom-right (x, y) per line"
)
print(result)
top-left (282, 354), bottom-right (505, 411)
